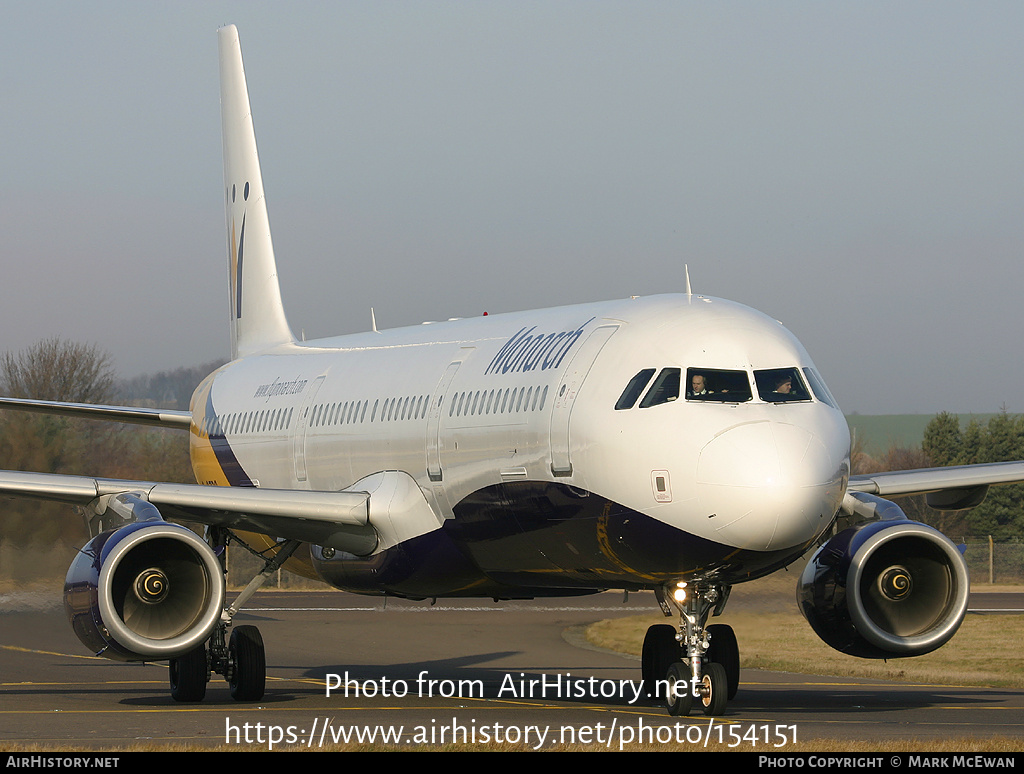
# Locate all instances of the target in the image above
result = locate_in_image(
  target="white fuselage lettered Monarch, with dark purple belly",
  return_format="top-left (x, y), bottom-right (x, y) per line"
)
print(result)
top-left (193, 295), bottom-right (850, 596)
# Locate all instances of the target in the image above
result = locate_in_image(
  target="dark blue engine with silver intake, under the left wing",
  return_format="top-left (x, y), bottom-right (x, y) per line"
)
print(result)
top-left (65, 521), bottom-right (224, 661)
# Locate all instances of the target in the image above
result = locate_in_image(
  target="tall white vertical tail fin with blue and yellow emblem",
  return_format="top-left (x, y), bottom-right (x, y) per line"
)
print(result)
top-left (217, 25), bottom-right (295, 358)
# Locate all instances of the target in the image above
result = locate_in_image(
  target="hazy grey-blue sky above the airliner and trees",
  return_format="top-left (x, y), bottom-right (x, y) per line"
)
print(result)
top-left (0, 0), bottom-right (1024, 414)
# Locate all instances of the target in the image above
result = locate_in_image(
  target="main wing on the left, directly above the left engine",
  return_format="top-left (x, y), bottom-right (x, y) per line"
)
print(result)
top-left (0, 471), bottom-right (377, 554)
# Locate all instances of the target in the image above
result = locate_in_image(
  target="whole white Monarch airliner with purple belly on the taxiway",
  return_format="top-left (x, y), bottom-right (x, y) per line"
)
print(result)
top-left (0, 27), bottom-right (1024, 716)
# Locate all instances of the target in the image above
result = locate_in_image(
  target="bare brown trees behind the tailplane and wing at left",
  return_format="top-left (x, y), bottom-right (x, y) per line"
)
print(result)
top-left (0, 338), bottom-right (220, 577)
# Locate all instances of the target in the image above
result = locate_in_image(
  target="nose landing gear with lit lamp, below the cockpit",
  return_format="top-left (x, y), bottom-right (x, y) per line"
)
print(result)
top-left (642, 583), bottom-right (739, 716)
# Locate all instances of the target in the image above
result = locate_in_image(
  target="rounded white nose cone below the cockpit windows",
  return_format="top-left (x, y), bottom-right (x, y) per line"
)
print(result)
top-left (696, 422), bottom-right (847, 551)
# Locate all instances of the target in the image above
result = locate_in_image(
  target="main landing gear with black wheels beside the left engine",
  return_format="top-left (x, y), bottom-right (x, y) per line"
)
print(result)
top-left (170, 530), bottom-right (299, 702)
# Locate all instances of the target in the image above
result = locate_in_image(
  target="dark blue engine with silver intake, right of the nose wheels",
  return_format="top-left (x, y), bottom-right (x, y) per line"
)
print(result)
top-left (797, 519), bottom-right (970, 658)
